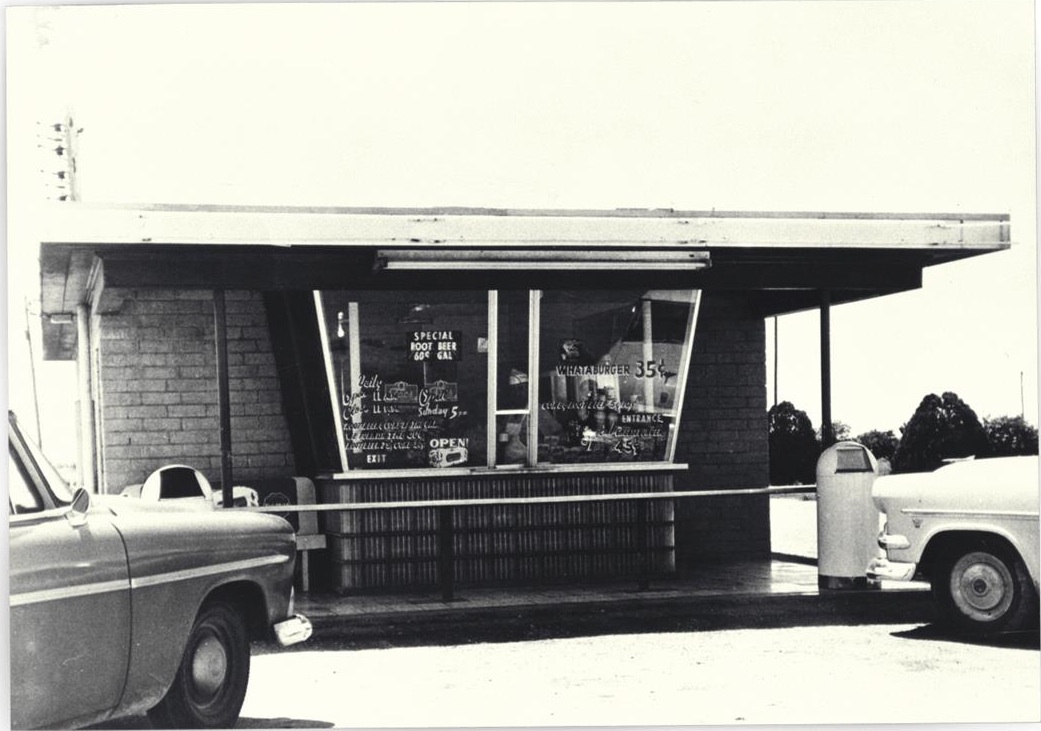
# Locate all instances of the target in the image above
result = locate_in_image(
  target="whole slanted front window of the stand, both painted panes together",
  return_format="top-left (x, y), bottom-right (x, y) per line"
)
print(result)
top-left (316, 289), bottom-right (697, 471)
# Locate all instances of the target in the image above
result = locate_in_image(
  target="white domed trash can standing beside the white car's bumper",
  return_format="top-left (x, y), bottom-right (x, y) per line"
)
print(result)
top-left (817, 442), bottom-right (880, 589)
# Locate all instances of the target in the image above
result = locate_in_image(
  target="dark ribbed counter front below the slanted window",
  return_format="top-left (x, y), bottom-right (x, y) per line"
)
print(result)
top-left (318, 464), bottom-right (677, 594)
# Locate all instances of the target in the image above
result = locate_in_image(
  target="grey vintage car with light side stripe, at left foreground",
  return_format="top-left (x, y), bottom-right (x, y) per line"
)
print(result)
top-left (7, 414), bottom-right (311, 728)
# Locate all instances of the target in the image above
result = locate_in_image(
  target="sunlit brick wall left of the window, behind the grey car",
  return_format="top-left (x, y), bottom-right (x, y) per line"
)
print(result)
top-left (95, 288), bottom-right (294, 493)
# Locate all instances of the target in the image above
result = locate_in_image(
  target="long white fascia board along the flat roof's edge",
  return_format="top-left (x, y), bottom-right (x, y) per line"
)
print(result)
top-left (41, 203), bottom-right (1010, 251)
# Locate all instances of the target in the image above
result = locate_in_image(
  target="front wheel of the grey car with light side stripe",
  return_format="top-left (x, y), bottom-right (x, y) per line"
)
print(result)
top-left (148, 602), bottom-right (250, 729)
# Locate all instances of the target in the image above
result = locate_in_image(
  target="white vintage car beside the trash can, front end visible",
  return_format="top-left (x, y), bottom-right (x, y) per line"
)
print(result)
top-left (867, 457), bottom-right (1041, 635)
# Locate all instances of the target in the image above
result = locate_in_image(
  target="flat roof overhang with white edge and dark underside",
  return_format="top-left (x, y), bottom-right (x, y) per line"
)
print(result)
top-left (40, 203), bottom-right (1011, 359)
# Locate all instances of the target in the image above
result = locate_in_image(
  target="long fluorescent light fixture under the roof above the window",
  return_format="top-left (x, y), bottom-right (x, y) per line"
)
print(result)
top-left (376, 249), bottom-right (711, 271)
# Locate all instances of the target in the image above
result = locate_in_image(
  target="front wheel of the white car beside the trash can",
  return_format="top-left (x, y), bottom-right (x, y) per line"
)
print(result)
top-left (933, 547), bottom-right (1037, 635)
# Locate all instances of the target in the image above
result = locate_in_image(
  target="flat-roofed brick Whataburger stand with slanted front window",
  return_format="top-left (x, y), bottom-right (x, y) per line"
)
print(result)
top-left (34, 204), bottom-right (1009, 591)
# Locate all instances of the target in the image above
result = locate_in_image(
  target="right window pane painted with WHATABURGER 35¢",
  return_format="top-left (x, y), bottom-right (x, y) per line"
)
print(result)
top-left (537, 289), bottom-right (696, 463)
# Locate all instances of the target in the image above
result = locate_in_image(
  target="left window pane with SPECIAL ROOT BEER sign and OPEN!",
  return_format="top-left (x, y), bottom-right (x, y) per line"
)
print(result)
top-left (319, 291), bottom-right (488, 470)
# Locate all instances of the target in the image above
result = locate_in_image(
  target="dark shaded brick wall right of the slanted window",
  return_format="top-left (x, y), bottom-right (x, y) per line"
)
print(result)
top-left (675, 292), bottom-right (770, 570)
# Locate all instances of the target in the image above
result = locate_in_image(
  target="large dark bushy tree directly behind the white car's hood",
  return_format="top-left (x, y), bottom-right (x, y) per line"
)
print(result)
top-left (893, 392), bottom-right (990, 473)
